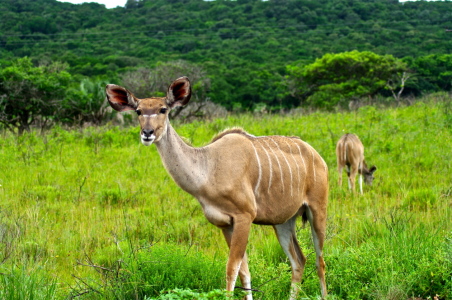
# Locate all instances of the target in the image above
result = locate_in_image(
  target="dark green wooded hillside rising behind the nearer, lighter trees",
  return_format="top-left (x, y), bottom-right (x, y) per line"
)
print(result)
top-left (0, 0), bottom-right (452, 111)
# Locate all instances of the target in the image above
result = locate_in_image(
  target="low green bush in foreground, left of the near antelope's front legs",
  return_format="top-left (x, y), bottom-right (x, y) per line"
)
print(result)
top-left (72, 241), bottom-right (228, 299)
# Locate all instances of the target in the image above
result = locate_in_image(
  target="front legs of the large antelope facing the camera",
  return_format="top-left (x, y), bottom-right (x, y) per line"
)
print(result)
top-left (222, 217), bottom-right (253, 300)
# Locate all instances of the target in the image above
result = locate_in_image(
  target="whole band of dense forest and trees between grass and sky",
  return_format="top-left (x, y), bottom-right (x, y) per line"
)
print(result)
top-left (0, 0), bottom-right (452, 130)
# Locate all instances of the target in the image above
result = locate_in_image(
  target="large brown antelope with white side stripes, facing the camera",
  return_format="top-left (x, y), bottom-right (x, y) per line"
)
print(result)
top-left (106, 77), bottom-right (328, 300)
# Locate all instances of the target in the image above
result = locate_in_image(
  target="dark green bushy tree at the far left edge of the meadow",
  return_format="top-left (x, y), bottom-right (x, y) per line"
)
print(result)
top-left (0, 57), bottom-right (71, 134)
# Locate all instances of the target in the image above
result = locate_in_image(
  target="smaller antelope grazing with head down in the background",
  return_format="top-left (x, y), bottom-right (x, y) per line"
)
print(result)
top-left (336, 133), bottom-right (377, 194)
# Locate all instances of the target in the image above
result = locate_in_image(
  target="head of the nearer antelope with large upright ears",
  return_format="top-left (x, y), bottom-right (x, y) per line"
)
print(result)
top-left (105, 77), bottom-right (191, 146)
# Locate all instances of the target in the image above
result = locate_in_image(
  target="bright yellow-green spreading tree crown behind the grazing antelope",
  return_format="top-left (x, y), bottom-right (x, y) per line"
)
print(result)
top-left (287, 50), bottom-right (407, 108)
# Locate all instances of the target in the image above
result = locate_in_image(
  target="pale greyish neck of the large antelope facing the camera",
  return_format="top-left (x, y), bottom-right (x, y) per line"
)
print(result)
top-left (155, 121), bottom-right (208, 195)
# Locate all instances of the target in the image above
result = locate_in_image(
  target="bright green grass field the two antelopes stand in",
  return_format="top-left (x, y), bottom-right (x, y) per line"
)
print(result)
top-left (0, 94), bottom-right (452, 300)
